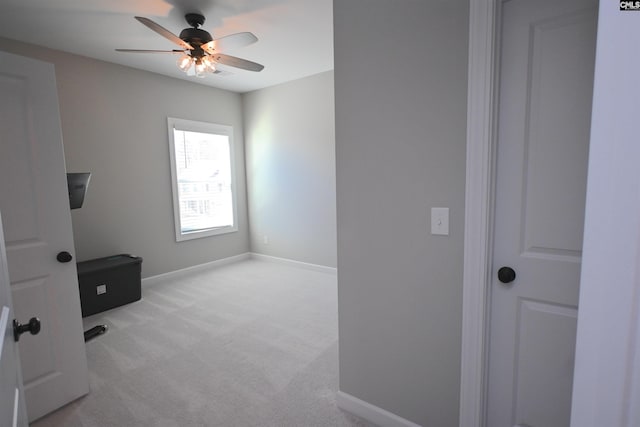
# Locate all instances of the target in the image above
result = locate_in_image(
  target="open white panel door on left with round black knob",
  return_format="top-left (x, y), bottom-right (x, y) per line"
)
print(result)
top-left (0, 52), bottom-right (89, 421)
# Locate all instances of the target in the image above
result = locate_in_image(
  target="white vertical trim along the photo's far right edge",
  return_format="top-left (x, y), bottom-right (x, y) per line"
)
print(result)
top-left (571, 1), bottom-right (640, 427)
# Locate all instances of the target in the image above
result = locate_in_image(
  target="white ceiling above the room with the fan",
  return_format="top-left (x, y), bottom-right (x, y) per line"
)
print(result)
top-left (0, 0), bottom-right (333, 92)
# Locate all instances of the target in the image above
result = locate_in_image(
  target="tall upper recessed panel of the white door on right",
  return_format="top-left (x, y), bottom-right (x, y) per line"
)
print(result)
top-left (522, 11), bottom-right (595, 261)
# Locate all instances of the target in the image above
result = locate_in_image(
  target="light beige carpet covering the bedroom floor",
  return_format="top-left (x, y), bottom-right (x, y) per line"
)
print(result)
top-left (32, 260), bottom-right (370, 427)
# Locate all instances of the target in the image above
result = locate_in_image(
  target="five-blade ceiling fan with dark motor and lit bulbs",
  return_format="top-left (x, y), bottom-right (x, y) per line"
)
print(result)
top-left (116, 13), bottom-right (264, 77)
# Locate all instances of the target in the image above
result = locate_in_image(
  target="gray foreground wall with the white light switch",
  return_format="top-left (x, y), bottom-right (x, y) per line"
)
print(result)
top-left (333, 0), bottom-right (468, 427)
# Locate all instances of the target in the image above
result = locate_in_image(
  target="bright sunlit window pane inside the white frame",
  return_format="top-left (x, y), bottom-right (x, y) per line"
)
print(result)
top-left (174, 129), bottom-right (234, 234)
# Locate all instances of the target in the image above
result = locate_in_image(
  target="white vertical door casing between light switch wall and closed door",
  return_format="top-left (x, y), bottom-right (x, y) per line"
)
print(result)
top-left (460, 0), bottom-right (502, 427)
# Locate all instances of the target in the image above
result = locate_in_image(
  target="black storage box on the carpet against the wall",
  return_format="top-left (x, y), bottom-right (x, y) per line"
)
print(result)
top-left (77, 254), bottom-right (142, 317)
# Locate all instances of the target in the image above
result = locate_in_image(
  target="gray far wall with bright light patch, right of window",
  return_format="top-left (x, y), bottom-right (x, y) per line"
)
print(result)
top-left (243, 71), bottom-right (336, 267)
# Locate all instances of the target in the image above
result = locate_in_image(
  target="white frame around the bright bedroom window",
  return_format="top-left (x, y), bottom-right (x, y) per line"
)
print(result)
top-left (167, 117), bottom-right (238, 242)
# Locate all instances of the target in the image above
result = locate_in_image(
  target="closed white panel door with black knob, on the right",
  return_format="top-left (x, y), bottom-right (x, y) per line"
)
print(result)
top-left (486, 0), bottom-right (596, 427)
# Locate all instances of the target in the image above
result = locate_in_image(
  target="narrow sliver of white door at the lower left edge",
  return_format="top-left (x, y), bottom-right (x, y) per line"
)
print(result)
top-left (0, 212), bottom-right (27, 427)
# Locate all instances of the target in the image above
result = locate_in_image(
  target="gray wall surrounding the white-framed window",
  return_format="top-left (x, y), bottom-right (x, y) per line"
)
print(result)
top-left (0, 39), bottom-right (249, 277)
